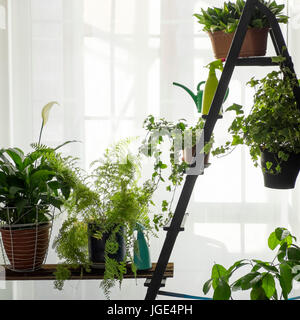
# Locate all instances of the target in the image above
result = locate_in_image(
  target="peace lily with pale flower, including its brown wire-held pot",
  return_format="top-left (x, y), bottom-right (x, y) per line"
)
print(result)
top-left (0, 102), bottom-right (80, 271)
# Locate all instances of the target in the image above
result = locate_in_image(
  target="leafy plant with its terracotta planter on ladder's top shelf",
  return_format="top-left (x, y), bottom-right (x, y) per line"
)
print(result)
top-left (194, 0), bottom-right (288, 59)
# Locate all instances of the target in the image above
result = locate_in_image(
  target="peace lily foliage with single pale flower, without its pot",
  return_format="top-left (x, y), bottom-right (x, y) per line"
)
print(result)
top-left (0, 102), bottom-right (81, 225)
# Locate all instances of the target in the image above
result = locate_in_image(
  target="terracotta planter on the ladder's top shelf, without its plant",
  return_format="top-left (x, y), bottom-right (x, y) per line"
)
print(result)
top-left (208, 28), bottom-right (269, 59)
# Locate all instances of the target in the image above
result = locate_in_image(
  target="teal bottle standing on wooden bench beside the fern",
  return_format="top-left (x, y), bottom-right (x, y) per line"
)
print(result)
top-left (134, 223), bottom-right (152, 270)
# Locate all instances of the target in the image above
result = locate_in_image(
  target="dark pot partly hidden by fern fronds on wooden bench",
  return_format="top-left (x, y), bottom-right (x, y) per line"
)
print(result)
top-left (88, 223), bottom-right (126, 269)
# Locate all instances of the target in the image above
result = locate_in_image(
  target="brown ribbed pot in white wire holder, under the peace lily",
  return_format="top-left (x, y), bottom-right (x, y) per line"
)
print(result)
top-left (0, 223), bottom-right (51, 271)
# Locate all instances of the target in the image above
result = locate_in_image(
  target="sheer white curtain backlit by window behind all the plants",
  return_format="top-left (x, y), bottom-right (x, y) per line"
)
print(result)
top-left (0, 0), bottom-right (300, 299)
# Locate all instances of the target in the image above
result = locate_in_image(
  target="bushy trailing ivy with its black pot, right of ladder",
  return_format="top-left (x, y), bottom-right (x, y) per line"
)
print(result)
top-left (213, 63), bottom-right (300, 189)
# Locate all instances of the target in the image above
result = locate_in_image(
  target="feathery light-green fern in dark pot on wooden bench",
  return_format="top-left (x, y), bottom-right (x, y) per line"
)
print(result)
top-left (54, 140), bottom-right (156, 298)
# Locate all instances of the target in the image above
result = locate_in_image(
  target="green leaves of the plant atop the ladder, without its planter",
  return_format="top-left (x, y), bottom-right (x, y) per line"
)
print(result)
top-left (194, 0), bottom-right (288, 33)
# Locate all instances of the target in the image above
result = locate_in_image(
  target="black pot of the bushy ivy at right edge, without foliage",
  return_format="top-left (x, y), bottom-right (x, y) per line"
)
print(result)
top-left (261, 151), bottom-right (300, 189)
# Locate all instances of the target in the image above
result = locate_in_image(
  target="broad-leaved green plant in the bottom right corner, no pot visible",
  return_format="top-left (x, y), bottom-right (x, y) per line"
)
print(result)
top-left (203, 228), bottom-right (300, 300)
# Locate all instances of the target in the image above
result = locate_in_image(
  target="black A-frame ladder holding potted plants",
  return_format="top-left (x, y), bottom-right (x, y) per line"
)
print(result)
top-left (145, 0), bottom-right (300, 300)
